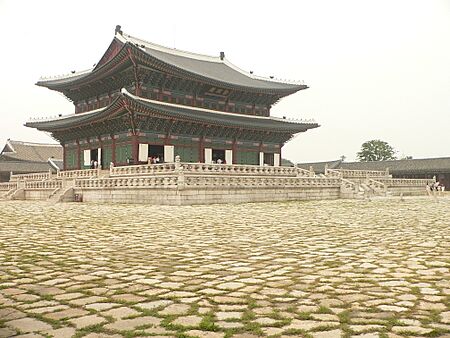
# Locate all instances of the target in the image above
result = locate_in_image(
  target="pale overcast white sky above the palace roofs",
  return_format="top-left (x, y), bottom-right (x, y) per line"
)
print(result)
top-left (0, 0), bottom-right (450, 162)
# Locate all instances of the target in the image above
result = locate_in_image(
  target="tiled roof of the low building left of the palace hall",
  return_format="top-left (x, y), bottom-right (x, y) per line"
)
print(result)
top-left (0, 139), bottom-right (63, 163)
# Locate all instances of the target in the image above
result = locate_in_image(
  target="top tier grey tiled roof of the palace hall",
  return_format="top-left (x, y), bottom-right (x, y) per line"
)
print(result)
top-left (37, 26), bottom-right (307, 95)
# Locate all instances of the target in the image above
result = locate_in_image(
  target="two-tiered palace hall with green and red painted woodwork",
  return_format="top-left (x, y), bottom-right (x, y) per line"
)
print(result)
top-left (25, 26), bottom-right (319, 170)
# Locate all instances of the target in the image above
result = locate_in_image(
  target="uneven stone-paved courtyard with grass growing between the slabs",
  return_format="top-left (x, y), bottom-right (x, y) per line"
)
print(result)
top-left (0, 196), bottom-right (450, 338)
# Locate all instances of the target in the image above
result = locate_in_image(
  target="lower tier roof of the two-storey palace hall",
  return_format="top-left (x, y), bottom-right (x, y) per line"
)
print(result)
top-left (25, 89), bottom-right (319, 133)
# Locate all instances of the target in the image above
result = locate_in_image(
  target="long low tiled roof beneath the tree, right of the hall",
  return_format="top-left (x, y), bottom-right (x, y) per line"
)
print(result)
top-left (298, 157), bottom-right (450, 174)
